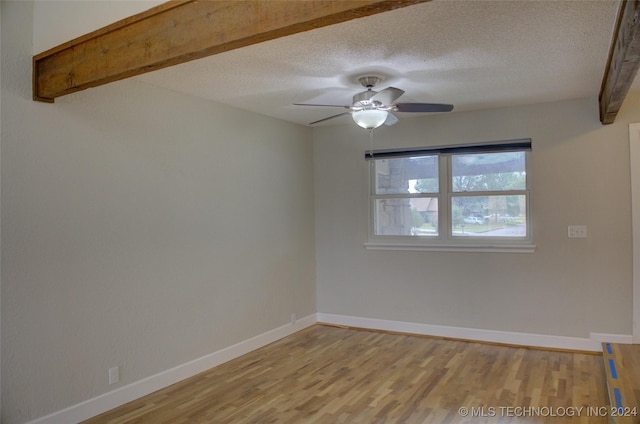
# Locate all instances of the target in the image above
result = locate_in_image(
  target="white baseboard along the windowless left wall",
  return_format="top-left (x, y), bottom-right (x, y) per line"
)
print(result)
top-left (28, 314), bottom-right (316, 424)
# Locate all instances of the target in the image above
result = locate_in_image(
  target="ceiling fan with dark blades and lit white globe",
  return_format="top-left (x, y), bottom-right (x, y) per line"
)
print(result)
top-left (294, 76), bottom-right (453, 130)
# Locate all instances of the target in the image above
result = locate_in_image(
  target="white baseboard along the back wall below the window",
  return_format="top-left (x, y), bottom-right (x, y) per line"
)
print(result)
top-left (317, 313), bottom-right (631, 352)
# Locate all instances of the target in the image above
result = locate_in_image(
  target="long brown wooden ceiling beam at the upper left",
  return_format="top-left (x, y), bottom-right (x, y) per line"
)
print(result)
top-left (33, 0), bottom-right (428, 102)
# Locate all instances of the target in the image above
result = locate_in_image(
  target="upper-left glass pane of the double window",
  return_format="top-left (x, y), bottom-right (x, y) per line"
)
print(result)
top-left (375, 156), bottom-right (439, 194)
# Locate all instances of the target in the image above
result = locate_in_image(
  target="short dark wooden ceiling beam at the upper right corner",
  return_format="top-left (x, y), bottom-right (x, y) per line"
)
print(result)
top-left (599, 0), bottom-right (640, 125)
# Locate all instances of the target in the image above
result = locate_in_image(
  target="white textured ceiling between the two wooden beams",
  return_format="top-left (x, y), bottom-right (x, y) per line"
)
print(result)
top-left (130, 0), bottom-right (624, 125)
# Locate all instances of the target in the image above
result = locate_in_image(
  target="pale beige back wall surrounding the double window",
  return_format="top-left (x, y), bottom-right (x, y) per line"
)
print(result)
top-left (314, 94), bottom-right (640, 338)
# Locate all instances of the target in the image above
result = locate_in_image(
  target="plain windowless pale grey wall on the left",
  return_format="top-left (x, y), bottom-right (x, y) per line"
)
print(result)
top-left (1, 2), bottom-right (315, 424)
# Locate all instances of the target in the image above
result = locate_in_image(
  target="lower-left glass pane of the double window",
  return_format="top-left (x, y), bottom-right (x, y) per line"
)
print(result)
top-left (375, 197), bottom-right (438, 236)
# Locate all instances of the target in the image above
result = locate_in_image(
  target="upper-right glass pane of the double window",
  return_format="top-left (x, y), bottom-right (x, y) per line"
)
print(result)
top-left (451, 152), bottom-right (527, 192)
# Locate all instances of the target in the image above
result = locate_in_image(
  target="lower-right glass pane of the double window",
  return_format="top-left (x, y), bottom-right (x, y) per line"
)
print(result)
top-left (451, 195), bottom-right (527, 237)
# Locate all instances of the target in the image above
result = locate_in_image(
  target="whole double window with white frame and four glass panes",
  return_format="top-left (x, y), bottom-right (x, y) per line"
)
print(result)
top-left (367, 140), bottom-right (533, 251)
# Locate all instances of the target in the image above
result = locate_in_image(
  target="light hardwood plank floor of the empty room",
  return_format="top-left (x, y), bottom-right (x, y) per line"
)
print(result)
top-left (85, 325), bottom-right (609, 424)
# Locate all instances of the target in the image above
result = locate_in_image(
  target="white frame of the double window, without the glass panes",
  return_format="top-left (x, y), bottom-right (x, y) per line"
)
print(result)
top-left (365, 139), bottom-right (535, 253)
